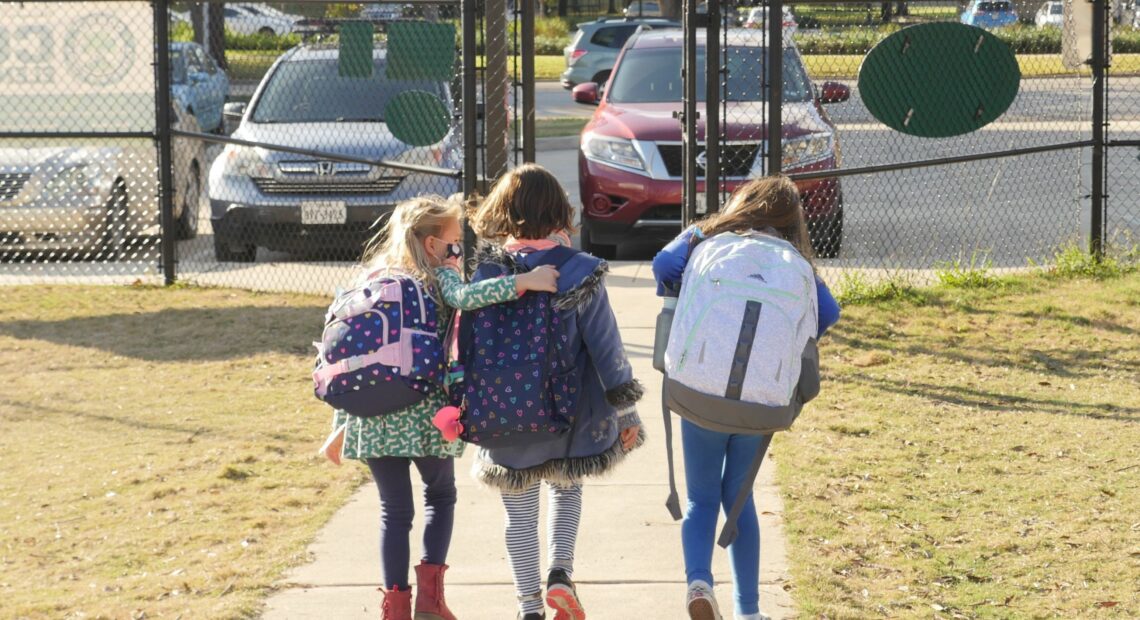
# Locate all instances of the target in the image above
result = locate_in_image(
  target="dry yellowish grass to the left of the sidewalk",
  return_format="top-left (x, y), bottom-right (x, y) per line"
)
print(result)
top-left (0, 287), bottom-right (363, 618)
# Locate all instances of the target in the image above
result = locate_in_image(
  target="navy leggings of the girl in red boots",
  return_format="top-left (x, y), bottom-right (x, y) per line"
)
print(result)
top-left (366, 456), bottom-right (455, 589)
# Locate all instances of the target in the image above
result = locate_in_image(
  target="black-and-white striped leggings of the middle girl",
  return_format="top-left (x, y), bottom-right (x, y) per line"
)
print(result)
top-left (503, 481), bottom-right (581, 614)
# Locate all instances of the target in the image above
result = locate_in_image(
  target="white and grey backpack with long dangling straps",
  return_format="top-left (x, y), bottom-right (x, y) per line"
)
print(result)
top-left (661, 233), bottom-right (820, 547)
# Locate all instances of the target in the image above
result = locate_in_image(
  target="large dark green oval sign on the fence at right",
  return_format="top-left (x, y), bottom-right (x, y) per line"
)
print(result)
top-left (858, 23), bottom-right (1021, 138)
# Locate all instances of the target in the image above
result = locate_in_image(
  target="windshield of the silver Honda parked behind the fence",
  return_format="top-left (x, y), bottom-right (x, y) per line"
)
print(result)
top-left (252, 58), bottom-right (450, 123)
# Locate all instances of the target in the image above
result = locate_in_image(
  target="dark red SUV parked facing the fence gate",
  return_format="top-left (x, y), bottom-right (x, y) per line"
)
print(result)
top-left (573, 28), bottom-right (850, 258)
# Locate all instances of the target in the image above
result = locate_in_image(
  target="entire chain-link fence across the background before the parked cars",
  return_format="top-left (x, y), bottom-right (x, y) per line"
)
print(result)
top-left (0, 0), bottom-right (1140, 293)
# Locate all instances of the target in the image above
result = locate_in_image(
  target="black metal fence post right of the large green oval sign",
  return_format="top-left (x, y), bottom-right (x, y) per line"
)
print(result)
top-left (1089, 0), bottom-right (1110, 261)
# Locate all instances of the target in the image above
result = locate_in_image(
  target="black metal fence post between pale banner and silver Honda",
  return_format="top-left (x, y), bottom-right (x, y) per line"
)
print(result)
top-left (152, 0), bottom-right (175, 285)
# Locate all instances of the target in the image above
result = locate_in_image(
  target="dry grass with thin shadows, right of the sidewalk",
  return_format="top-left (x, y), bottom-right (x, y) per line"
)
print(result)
top-left (774, 272), bottom-right (1140, 618)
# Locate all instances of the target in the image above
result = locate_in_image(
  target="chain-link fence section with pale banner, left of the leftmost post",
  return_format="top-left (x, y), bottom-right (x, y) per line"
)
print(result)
top-left (0, 2), bottom-right (166, 283)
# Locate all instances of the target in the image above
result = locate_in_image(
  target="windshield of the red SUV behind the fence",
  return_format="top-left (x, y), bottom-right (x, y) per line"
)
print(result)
top-left (608, 47), bottom-right (812, 104)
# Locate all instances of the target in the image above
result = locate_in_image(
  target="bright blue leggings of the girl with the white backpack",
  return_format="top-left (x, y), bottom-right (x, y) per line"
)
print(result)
top-left (681, 419), bottom-right (763, 614)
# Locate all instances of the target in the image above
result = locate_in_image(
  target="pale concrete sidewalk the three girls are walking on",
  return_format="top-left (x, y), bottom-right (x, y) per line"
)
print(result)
top-left (262, 262), bottom-right (795, 620)
